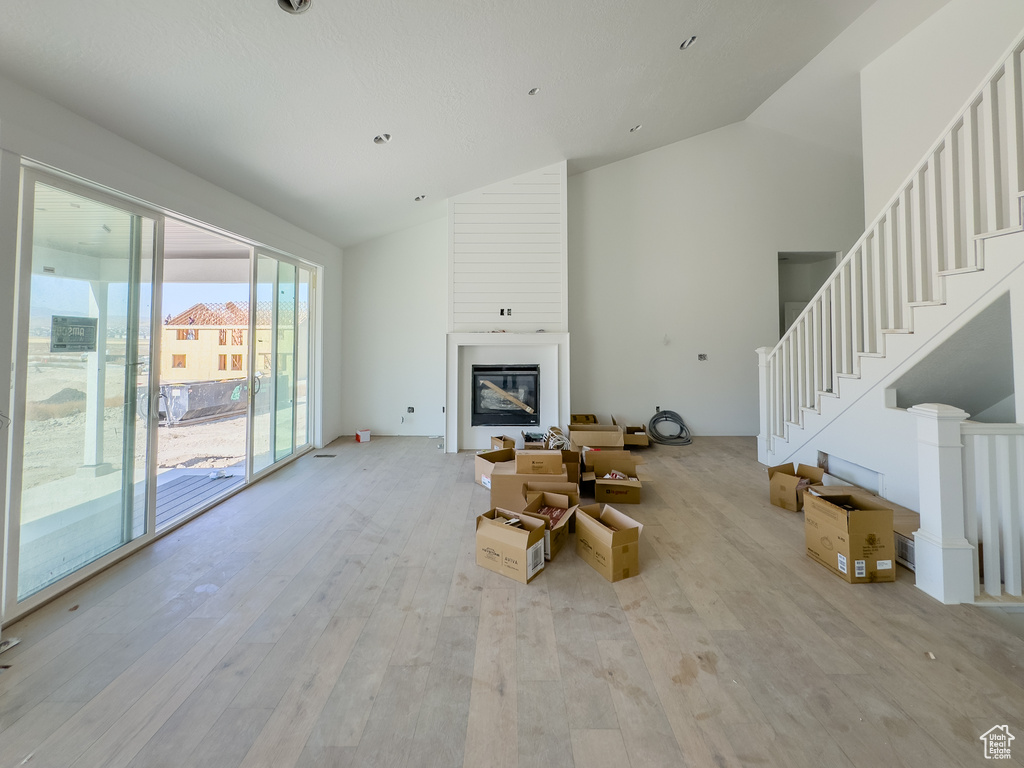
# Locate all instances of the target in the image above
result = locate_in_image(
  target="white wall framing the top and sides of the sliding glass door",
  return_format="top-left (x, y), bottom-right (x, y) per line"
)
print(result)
top-left (0, 73), bottom-right (342, 441)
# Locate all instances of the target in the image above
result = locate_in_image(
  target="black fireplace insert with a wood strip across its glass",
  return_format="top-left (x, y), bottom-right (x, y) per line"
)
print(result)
top-left (472, 366), bottom-right (541, 427)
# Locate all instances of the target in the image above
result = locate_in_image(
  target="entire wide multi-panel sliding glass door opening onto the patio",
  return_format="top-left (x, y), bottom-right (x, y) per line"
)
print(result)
top-left (0, 167), bottom-right (316, 620)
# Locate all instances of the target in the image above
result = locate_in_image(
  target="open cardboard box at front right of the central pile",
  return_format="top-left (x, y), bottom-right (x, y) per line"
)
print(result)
top-left (575, 504), bottom-right (643, 582)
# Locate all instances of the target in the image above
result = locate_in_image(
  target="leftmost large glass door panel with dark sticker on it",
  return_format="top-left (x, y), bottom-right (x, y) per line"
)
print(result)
top-left (14, 177), bottom-right (156, 601)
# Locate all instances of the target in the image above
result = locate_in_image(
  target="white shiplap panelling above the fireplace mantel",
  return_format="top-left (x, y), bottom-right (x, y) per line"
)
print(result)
top-left (449, 162), bottom-right (568, 333)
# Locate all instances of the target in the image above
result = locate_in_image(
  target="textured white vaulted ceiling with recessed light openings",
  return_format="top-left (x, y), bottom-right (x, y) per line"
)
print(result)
top-left (0, 0), bottom-right (872, 246)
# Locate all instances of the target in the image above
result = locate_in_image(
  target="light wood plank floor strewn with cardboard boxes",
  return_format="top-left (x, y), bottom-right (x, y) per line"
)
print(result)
top-left (0, 436), bottom-right (1024, 768)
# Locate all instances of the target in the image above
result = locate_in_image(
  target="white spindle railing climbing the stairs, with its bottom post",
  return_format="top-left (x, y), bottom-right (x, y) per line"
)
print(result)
top-left (758, 35), bottom-right (1024, 454)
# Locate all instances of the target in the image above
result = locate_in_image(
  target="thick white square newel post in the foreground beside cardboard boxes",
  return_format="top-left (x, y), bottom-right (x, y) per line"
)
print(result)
top-left (908, 402), bottom-right (974, 604)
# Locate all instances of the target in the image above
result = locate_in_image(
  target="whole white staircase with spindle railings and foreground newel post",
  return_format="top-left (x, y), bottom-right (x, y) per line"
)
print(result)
top-left (758, 35), bottom-right (1024, 602)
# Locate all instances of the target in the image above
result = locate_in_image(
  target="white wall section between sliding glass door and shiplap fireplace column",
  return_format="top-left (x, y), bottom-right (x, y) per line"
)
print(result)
top-left (342, 217), bottom-right (447, 435)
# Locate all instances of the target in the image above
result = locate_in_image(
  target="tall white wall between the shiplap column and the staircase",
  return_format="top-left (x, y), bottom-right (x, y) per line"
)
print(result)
top-left (568, 123), bottom-right (862, 435)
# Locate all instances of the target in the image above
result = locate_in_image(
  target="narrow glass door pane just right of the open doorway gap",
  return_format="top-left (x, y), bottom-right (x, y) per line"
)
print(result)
top-left (250, 254), bottom-right (278, 473)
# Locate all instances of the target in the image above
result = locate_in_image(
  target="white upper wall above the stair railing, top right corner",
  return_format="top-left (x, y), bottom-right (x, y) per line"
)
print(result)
top-left (860, 0), bottom-right (1024, 224)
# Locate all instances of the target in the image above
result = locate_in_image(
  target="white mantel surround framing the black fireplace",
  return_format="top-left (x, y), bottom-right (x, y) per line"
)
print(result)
top-left (444, 333), bottom-right (569, 454)
